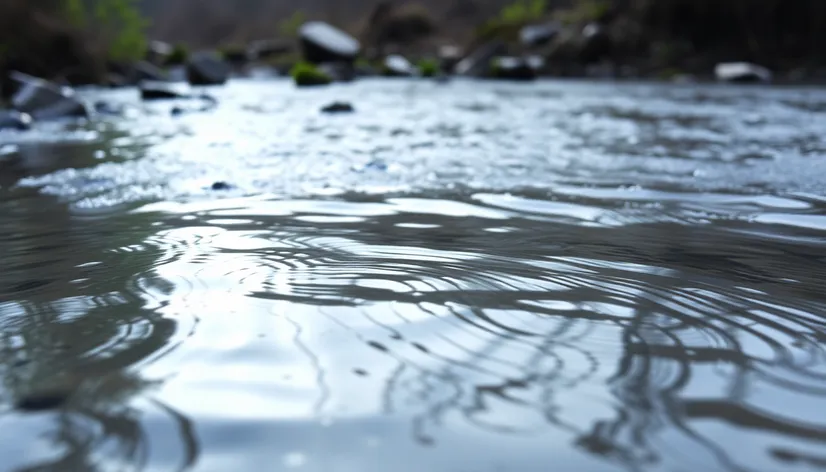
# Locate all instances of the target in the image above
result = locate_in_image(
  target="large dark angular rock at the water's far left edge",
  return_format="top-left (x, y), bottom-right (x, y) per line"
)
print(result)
top-left (10, 72), bottom-right (89, 120)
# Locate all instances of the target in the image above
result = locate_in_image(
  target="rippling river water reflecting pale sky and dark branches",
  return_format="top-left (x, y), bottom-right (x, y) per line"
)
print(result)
top-left (0, 80), bottom-right (826, 472)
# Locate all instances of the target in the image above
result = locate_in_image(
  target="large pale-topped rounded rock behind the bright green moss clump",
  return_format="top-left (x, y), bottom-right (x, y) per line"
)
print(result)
top-left (299, 21), bottom-right (361, 64)
